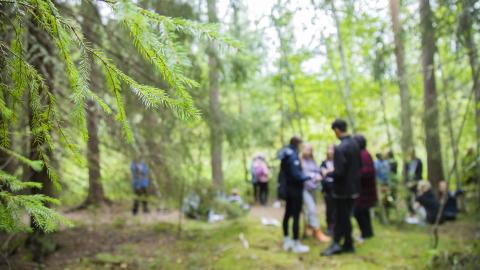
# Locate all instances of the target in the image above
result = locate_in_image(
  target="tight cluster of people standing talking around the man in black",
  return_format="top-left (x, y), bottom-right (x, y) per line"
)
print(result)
top-left (278, 119), bottom-right (364, 256)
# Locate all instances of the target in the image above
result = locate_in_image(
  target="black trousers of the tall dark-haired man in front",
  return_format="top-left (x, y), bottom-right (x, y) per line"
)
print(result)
top-left (333, 198), bottom-right (353, 248)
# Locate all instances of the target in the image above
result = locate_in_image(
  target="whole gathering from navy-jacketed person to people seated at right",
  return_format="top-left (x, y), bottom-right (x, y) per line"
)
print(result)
top-left (278, 119), bottom-right (458, 256)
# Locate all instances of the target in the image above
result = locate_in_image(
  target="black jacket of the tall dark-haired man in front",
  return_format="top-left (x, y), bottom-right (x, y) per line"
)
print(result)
top-left (333, 136), bottom-right (362, 198)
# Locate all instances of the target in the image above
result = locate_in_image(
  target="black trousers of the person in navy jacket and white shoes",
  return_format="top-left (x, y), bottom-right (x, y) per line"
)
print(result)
top-left (283, 187), bottom-right (303, 240)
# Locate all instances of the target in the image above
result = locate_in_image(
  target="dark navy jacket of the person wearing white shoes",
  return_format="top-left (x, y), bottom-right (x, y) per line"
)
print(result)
top-left (279, 145), bottom-right (310, 191)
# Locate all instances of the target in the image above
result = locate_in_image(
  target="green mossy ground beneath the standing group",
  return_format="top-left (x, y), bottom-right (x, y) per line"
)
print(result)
top-left (62, 213), bottom-right (479, 270)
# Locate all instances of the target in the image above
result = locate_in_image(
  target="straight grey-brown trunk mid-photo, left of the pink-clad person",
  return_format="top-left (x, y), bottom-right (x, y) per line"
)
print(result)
top-left (207, 0), bottom-right (223, 190)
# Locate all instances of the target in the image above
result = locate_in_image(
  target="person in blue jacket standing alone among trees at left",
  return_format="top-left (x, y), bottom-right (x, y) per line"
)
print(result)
top-left (130, 158), bottom-right (149, 215)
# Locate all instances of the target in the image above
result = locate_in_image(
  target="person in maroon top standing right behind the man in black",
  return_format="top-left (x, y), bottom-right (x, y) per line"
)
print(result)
top-left (353, 135), bottom-right (377, 241)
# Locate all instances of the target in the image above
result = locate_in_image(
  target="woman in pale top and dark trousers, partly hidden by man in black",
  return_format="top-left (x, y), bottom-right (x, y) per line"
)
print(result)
top-left (320, 144), bottom-right (335, 236)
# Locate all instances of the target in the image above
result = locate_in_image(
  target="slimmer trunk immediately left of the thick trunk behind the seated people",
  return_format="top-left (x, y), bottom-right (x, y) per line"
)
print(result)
top-left (390, 0), bottom-right (413, 173)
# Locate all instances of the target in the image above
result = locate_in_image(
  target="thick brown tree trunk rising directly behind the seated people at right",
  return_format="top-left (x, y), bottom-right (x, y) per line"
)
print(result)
top-left (419, 0), bottom-right (444, 191)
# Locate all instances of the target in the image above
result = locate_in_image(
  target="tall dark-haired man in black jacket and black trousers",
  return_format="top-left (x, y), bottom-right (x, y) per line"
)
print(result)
top-left (321, 119), bottom-right (362, 256)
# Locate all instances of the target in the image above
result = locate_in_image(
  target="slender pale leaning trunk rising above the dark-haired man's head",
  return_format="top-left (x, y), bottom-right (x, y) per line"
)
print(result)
top-left (330, 0), bottom-right (356, 133)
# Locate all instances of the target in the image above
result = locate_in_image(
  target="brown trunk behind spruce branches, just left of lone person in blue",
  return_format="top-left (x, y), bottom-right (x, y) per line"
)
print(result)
top-left (81, 0), bottom-right (106, 207)
